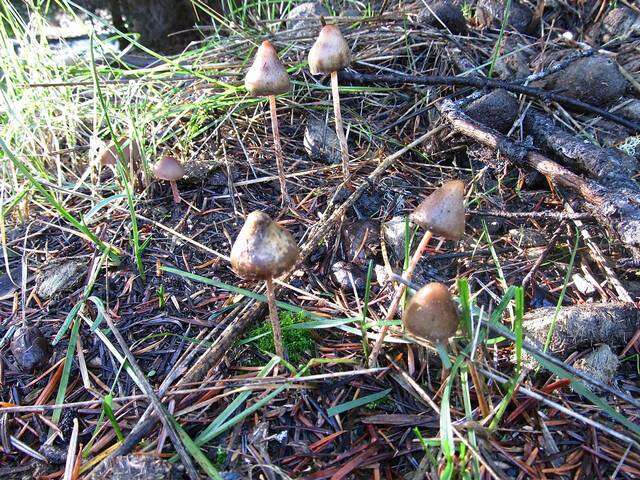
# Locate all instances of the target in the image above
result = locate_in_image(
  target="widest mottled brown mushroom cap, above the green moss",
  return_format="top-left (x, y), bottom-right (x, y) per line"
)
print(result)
top-left (231, 211), bottom-right (299, 280)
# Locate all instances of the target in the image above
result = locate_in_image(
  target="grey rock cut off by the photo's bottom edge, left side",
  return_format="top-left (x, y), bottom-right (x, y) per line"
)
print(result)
top-left (87, 455), bottom-right (184, 480)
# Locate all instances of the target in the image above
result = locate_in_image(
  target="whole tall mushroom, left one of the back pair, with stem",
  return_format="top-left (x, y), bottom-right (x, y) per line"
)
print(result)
top-left (244, 40), bottom-right (291, 205)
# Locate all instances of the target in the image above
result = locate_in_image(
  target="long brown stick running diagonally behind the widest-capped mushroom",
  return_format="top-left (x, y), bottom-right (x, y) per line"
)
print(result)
top-left (178, 125), bottom-right (445, 383)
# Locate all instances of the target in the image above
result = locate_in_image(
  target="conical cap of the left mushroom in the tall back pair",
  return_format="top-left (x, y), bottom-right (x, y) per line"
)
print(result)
top-left (244, 40), bottom-right (290, 97)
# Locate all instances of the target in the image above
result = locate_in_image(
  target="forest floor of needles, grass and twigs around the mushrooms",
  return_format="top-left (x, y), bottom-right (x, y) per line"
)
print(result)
top-left (0, 0), bottom-right (640, 480)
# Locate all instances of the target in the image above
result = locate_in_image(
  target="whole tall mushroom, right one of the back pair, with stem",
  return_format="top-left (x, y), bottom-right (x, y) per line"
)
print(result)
top-left (309, 21), bottom-right (351, 180)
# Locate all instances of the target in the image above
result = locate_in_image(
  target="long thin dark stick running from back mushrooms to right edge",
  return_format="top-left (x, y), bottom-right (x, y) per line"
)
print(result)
top-left (340, 71), bottom-right (640, 132)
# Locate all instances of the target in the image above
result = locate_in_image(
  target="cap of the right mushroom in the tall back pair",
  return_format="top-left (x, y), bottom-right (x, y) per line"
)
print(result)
top-left (309, 25), bottom-right (351, 75)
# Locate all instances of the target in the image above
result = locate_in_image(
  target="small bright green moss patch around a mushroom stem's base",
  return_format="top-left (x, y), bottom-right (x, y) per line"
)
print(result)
top-left (248, 312), bottom-right (316, 365)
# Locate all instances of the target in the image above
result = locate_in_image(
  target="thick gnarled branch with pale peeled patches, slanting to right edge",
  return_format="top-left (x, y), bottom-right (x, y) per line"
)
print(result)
top-left (438, 100), bottom-right (640, 255)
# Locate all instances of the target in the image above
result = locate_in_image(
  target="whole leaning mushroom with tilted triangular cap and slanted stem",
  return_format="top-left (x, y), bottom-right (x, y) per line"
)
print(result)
top-left (369, 180), bottom-right (465, 366)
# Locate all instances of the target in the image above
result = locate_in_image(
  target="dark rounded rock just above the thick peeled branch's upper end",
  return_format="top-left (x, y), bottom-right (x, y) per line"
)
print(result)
top-left (464, 89), bottom-right (519, 133)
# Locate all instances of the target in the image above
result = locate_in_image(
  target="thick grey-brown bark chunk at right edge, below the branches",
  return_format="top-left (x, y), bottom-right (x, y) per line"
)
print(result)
top-left (522, 302), bottom-right (640, 358)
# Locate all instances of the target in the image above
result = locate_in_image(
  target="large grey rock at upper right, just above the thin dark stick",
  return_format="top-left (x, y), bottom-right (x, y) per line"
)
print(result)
top-left (545, 55), bottom-right (628, 106)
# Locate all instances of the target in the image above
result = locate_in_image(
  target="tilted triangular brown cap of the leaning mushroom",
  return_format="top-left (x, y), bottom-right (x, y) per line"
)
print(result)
top-left (411, 180), bottom-right (464, 240)
